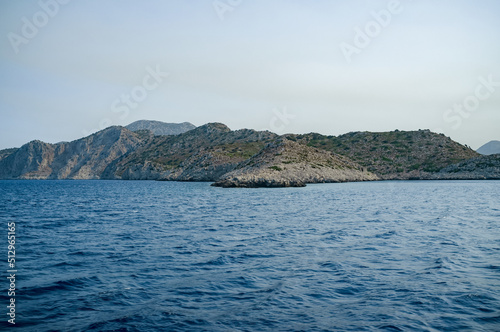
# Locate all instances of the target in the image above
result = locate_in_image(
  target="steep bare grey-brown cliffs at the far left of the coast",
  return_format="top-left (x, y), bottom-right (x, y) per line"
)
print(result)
top-left (0, 127), bottom-right (144, 179)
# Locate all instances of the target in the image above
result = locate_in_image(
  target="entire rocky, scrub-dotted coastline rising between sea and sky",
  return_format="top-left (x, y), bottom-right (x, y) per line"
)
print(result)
top-left (0, 120), bottom-right (500, 187)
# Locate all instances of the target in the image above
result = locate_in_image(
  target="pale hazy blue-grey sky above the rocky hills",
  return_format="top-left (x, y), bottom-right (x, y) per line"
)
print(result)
top-left (0, 0), bottom-right (500, 149)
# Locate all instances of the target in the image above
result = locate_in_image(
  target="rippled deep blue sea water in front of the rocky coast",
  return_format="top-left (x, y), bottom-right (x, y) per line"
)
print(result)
top-left (0, 181), bottom-right (500, 331)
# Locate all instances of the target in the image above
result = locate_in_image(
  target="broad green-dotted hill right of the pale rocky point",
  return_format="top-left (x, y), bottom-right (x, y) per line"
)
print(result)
top-left (288, 130), bottom-right (479, 179)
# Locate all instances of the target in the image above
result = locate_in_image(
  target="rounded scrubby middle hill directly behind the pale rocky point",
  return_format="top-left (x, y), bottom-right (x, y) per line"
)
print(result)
top-left (106, 123), bottom-right (277, 181)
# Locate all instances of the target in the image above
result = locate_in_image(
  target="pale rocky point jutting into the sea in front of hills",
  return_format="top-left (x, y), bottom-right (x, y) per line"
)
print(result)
top-left (213, 138), bottom-right (379, 187)
